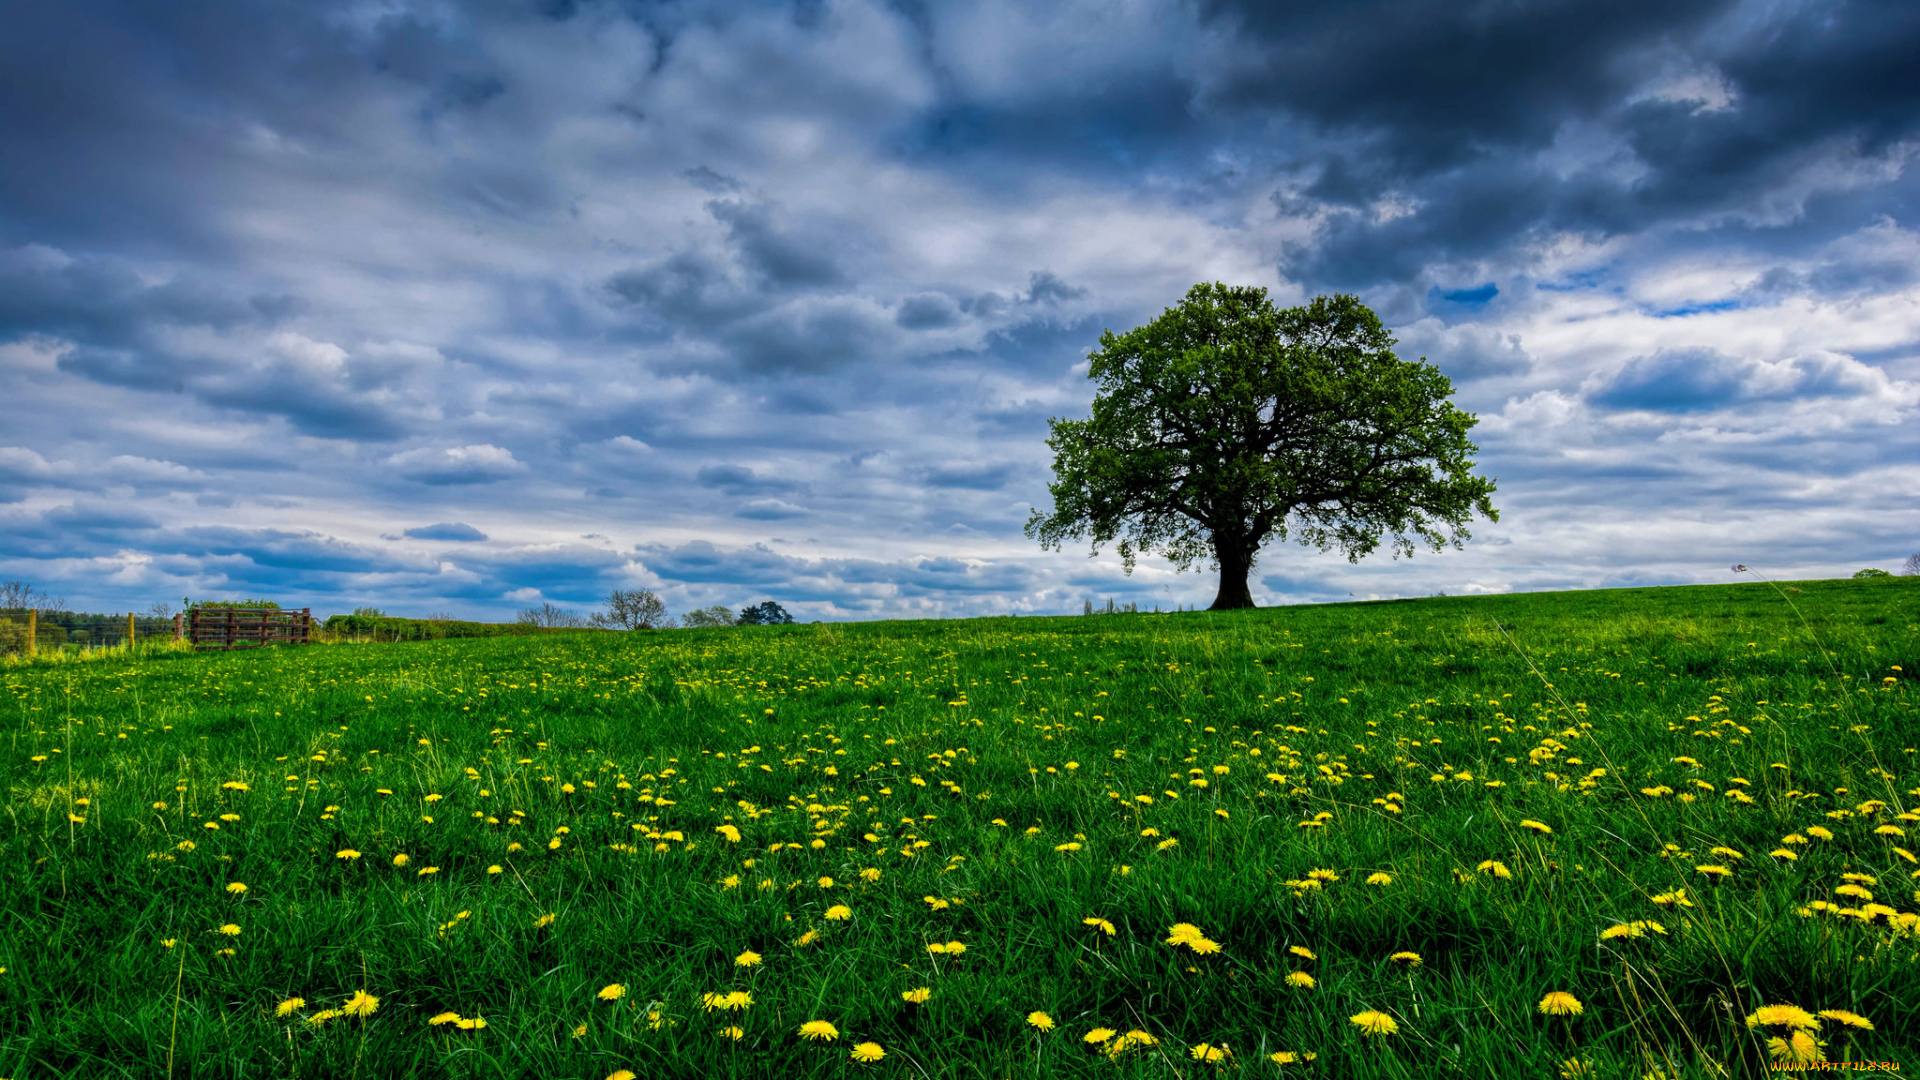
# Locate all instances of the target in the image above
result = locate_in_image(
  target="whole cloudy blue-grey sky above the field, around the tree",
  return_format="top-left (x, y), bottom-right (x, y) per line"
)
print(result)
top-left (0, 0), bottom-right (1920, 621)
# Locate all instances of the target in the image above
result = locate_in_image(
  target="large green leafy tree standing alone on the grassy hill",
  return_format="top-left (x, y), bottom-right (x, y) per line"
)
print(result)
top-left (1027, 284), bottom-right (1500, 611)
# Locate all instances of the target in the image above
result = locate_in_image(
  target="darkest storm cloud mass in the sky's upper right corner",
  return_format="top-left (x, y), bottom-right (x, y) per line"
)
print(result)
top-left (1208, 0), bottom-right (1920, 286)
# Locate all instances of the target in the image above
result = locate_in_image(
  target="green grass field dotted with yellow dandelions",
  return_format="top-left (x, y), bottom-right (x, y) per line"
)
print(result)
top-left (0, 578), bottom-right (1920, 1080)
